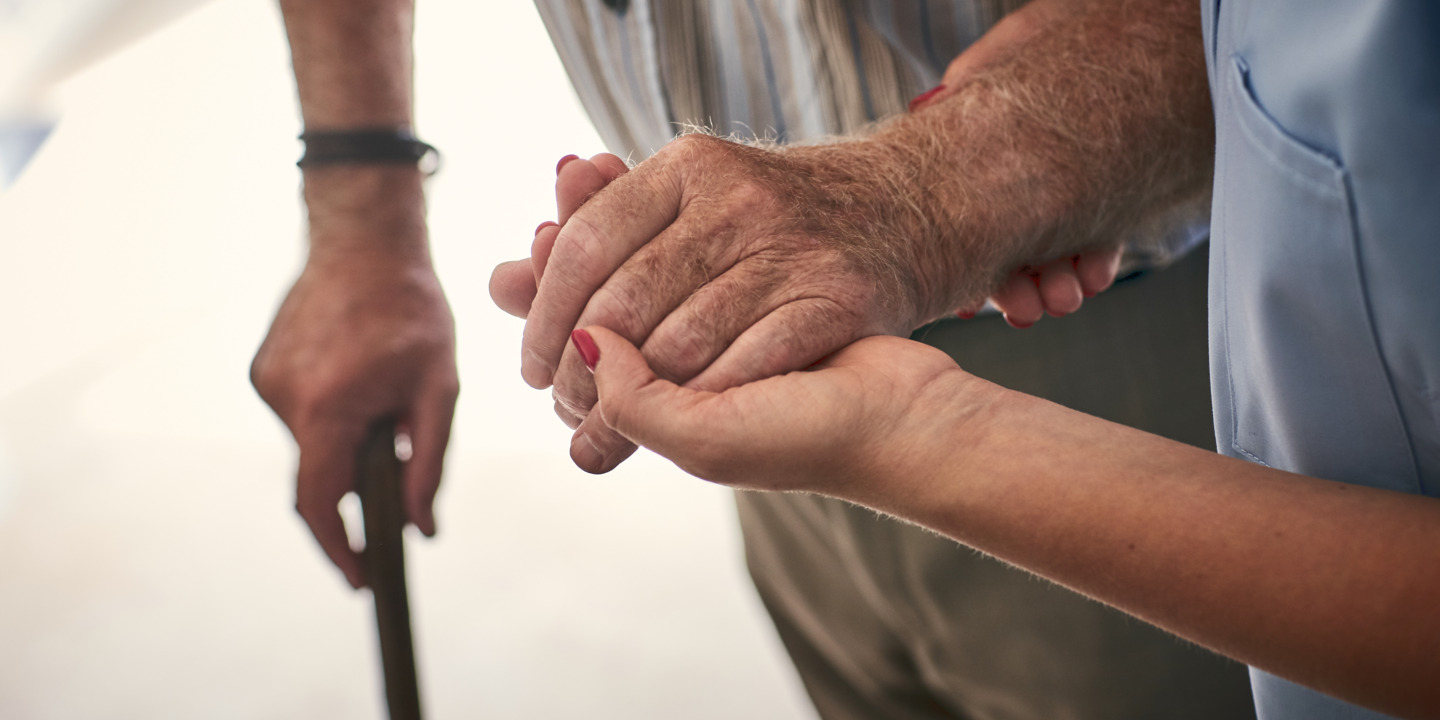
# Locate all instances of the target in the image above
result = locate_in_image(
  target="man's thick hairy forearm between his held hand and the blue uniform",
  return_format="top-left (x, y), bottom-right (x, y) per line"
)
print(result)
top-left (786, 0), bottom-right (1214, 321)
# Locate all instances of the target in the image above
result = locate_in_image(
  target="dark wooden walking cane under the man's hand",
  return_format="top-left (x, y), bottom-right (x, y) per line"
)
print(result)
top-left (356, 420), bottom-right (420, 720)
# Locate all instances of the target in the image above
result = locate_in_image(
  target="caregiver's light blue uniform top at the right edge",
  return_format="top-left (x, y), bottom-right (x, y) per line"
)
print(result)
top-left (1202, 0), bottom-right (1440, 720)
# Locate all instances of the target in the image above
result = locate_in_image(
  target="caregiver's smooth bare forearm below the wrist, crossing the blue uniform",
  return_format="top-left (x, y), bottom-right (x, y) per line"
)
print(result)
top-left (875, 373), bottom-right (1440, 717)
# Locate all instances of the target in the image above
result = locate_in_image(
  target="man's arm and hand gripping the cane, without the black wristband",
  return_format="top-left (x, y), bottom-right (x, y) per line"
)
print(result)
top-left (251, 0), bottom-right (459, 586)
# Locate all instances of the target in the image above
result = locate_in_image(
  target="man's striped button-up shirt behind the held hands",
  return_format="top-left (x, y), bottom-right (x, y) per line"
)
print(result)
top-left (536, 0), bottom-right (1210, 269)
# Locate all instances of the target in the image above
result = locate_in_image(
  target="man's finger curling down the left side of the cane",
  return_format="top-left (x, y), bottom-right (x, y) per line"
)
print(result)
top-left (295, 433), bottom-right (364, 589)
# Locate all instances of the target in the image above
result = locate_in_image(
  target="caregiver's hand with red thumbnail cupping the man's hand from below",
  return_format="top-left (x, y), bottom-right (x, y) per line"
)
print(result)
top-left (572, 327), bottom-right (1004, 505)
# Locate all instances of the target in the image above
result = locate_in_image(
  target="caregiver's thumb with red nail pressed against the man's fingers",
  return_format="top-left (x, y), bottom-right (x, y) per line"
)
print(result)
top-left (570, 325), bottom-right (708, 459)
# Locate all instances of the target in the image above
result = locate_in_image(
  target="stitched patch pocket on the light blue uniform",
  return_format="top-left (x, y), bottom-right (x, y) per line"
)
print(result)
top-left (1211, 55), bottom-right (1418, 491)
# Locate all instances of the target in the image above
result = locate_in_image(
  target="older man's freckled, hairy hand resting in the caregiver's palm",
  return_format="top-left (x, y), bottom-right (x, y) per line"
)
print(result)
top-left (512, 135), bottom-right (943, 472)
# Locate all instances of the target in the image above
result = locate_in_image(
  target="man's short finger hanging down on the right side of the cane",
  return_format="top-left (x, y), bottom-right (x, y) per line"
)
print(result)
top-left (405, 376), bottom-right (459, 537)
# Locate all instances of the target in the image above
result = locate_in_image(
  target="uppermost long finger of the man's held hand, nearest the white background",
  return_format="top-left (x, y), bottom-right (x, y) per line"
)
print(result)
top-left (521, 156), bottom-right (683, 387)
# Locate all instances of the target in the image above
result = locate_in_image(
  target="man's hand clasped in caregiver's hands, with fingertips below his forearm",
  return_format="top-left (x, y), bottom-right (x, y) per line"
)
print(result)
top-left (491, 135), bottom-right (1119, 480)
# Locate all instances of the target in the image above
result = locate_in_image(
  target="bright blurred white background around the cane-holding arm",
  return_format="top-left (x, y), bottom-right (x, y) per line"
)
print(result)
top-left (0, 0), bottom-right (812, 720)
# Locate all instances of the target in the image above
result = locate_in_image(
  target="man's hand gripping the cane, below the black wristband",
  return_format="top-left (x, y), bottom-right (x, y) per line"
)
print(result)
top-left (251, 251), bottom-right (459, 588)
